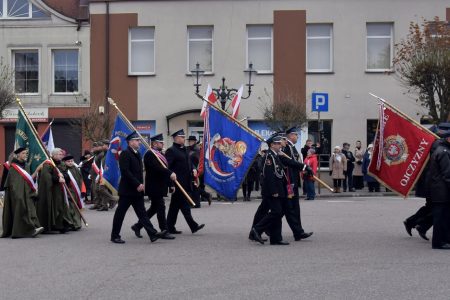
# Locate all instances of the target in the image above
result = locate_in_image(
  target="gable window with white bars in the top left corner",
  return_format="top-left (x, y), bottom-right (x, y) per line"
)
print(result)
top-left (0, 0), bottom-right (50, 19)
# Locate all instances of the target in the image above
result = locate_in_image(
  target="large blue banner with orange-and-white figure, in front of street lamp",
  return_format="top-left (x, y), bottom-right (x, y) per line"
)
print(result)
top-left (203, 107), bottom-right (261, 200)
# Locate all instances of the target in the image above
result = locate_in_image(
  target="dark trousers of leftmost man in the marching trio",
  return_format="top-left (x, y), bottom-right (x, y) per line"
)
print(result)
top-left (111, 196), bottom-right (157, 239)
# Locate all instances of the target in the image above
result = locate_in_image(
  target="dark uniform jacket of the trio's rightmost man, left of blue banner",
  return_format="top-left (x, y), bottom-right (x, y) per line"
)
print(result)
top-left (166, 143), bottom-right (193, 192)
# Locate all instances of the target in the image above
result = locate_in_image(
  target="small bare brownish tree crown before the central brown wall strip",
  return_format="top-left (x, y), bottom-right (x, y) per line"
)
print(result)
top-left (259, 89), bottom-right (308, 131)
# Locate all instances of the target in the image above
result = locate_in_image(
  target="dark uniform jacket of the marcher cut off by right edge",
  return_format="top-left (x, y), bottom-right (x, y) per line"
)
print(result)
top-left (429, 140), bottom-right (450, 203)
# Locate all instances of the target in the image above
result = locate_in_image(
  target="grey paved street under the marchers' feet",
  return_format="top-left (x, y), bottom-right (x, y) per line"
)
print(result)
top-left (0, 197), bottom-right (450, 300)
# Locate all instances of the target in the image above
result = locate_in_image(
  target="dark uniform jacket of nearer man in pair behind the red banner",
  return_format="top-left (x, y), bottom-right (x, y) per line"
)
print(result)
top-left (261, 149), bottom-right (287, 198)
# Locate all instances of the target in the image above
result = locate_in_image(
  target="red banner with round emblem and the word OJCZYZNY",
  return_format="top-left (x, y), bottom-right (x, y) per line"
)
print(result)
top-left (369, 105), bottom-right (436, 197)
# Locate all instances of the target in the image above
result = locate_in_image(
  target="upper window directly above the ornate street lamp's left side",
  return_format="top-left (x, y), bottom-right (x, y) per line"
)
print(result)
top-left (187, 26), bottom-right (213, 74)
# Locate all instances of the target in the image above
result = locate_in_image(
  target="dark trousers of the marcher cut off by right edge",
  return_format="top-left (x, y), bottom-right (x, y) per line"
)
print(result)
top-left (431, 202), bottom-right (450, 248)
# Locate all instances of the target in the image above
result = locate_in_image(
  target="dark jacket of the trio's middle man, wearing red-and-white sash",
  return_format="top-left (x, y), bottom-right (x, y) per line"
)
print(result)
top-left (144, 150), bottom-right (172, 198)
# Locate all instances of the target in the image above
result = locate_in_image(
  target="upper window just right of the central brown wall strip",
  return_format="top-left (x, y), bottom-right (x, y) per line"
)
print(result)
top-left (306, 24), bottom-right (333, 73)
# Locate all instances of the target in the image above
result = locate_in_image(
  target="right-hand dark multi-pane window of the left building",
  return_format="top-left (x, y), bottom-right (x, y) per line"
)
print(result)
top-left (53, 49), bottom-right (79, 93)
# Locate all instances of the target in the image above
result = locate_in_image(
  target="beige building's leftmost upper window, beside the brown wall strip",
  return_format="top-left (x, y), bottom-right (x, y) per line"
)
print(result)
top-left (128, 27), bottom-right (155, 75)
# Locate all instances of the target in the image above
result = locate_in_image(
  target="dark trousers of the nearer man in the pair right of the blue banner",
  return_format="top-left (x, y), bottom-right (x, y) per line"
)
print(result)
top-left (253, 197), bottom-right (288, 243)
